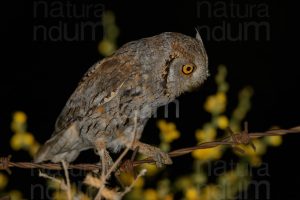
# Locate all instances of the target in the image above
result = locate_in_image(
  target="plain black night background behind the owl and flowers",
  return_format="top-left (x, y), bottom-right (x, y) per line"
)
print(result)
top-left (0, 0), bottom-right (300, 200)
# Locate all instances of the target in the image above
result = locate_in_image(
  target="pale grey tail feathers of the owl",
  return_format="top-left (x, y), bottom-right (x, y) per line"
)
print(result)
top-left (34, 125), bottom-right (81, 163)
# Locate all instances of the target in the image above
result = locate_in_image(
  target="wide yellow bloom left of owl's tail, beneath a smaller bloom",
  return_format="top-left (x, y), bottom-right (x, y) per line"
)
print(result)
top-left (10, 133), bottom-right (35, 151)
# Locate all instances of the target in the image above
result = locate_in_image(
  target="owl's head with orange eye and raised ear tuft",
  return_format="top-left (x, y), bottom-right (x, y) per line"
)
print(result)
top-left (162, 31), bottom-right (209, 97)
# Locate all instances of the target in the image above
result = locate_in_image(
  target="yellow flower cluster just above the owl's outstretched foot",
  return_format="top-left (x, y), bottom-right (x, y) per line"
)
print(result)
top-left (157, 120), bottom-right (180, 143)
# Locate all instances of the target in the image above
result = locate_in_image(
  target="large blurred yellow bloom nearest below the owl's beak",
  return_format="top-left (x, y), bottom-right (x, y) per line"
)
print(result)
top-left (204, 92), bottom-right (227, 114)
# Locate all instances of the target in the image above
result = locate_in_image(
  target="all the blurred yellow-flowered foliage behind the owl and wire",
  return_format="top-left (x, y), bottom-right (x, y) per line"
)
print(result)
top-left (0, 11), bottom-right (282, 200)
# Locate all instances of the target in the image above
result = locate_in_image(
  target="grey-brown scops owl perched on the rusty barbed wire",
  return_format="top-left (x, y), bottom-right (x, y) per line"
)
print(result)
top-left (35, 32), bottom-right (208, 164)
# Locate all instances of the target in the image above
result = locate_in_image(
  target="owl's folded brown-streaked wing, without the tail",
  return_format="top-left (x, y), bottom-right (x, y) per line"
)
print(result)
top-left (54, 55), bottom-right (133, 135)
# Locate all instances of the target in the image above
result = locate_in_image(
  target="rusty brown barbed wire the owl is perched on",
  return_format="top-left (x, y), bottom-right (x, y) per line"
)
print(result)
top-left (0, 123), bottom-right (300, 172)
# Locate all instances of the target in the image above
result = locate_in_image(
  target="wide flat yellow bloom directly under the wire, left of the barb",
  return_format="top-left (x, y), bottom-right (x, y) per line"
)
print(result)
top-left (192, 146), bottom-right (222, 160)
